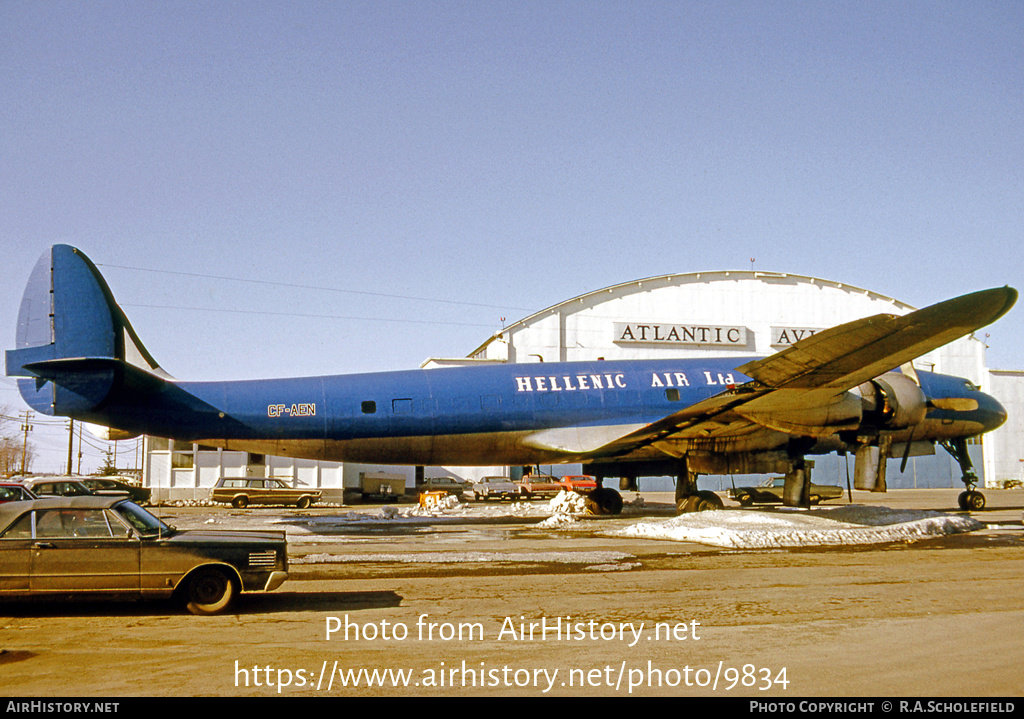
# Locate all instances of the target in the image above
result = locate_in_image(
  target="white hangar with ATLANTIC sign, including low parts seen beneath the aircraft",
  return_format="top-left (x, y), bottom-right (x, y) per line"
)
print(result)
top-left (144, 270), bottom-right (1024, 500)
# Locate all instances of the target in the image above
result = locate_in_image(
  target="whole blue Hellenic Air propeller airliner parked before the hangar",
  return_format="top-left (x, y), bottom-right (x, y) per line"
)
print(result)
top-left (6, 245), bottom-right (1017, 513)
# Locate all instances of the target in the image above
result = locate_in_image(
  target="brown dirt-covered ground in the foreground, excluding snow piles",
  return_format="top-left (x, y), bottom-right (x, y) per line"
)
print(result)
top-left (0, 490), bottom-right (1024, 699)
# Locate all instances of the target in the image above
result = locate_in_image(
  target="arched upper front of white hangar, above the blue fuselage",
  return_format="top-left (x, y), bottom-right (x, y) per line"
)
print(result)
top-left (454, 270), bottom-right (986, 381)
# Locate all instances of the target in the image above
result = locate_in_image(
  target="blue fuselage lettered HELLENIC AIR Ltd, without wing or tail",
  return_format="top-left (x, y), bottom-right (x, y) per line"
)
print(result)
top-left (58, 357), bottom-right (1006, 465)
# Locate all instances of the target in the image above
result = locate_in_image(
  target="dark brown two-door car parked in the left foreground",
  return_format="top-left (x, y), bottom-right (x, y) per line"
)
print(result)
top-left (0, 496), bottom-right (288, 615)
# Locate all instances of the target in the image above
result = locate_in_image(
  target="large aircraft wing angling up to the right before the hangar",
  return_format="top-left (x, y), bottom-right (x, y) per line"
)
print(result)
top-left (537, 287), bottom-right (1017, 460)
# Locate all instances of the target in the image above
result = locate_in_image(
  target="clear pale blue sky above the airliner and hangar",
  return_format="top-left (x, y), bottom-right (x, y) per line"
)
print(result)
top-left (0, 0), bottom-right (1024, 469)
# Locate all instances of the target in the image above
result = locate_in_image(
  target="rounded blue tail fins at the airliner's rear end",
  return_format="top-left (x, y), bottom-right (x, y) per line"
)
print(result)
top-left (6, 245), bottom-right (169, 417)
